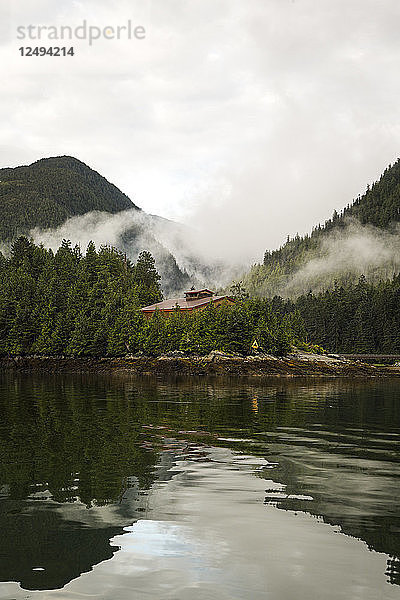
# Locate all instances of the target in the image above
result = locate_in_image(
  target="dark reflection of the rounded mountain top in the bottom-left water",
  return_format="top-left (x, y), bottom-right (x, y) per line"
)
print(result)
top-left (0, 500), bottom-right (122, 589)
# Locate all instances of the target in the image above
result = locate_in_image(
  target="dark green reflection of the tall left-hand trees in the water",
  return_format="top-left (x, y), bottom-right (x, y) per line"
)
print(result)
top-left (0, 379), bottom-right (155, 505)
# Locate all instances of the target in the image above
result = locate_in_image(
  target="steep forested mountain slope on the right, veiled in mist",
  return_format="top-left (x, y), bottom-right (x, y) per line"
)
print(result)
top-left (243, 159), bottom-right (400, 297)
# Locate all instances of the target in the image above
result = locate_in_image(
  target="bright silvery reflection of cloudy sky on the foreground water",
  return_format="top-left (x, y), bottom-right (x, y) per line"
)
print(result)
top-left (0, 448), bottom-right (398, 600)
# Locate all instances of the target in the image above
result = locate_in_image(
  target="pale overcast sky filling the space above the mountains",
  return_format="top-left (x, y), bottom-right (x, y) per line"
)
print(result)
top-left (0, 0), bottom-right (400, 262)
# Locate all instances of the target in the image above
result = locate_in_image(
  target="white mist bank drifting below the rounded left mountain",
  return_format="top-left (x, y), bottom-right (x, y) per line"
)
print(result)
top-left (29, 209), bottom-right (248, 294)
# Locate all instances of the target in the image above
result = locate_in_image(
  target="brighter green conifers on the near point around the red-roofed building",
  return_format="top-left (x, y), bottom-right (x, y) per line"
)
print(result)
top-left (0, 236), bottom-right (304, 356)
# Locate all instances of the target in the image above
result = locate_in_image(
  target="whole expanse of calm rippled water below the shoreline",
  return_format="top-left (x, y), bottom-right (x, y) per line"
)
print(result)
top-left (0, 374), bottom-right (400, 600)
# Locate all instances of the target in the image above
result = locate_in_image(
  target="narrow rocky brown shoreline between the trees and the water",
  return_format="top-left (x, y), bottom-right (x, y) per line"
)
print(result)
top-left (0, 352), bottom-right (400, 377)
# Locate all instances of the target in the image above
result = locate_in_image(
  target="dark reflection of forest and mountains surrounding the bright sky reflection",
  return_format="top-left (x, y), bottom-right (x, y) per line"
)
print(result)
top-left (0, 375), bottom-right (400, 597)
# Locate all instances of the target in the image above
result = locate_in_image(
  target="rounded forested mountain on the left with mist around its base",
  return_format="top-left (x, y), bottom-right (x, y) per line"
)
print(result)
top-left (0, 156), bottom-right (195, 294)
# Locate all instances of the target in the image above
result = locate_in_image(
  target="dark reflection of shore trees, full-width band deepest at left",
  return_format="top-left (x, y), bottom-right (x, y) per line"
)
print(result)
top-left (0, 376), bottom-right (400, 506)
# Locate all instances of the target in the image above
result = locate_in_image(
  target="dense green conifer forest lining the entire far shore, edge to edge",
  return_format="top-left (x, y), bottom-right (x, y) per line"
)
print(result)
top-left (0, 237), bottom-right (400, 356)
